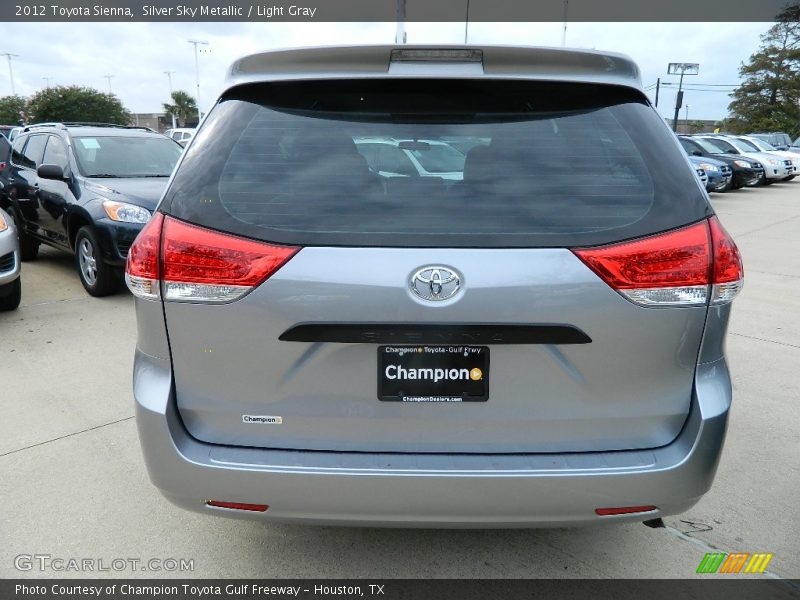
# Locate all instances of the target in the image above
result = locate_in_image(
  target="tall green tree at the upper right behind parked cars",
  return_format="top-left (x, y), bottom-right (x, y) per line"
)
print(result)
top-left (723, 4), bottom-right (800, 136)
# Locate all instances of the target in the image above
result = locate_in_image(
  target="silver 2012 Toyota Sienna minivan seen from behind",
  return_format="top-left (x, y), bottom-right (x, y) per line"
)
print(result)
top-left (127, 46), bottom-right (742, 527)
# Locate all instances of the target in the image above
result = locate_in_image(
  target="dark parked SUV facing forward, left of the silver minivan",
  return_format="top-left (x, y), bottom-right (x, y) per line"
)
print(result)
top-left (0, 123), bottom-right (182, 296)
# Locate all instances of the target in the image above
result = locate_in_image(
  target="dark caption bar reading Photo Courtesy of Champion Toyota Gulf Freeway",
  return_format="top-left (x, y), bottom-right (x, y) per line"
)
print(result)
top-left (0, 575), bottom-right (800, 600)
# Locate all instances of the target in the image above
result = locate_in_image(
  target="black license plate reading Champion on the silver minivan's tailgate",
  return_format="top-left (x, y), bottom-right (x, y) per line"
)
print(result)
top-left (378, 346), bottom-right (489, 402)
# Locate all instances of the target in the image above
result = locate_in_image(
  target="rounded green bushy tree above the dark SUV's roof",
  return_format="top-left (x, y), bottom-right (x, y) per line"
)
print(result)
top-left (28, 85), bottom-right (131, 125)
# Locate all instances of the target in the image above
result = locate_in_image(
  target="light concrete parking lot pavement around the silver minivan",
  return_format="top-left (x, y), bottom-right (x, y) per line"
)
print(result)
top-left (0, 182), bottom-right (800, 579)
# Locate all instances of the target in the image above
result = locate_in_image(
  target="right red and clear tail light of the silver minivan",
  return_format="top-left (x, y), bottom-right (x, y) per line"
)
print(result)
top-left (573, 217), bottom-right (743, 306)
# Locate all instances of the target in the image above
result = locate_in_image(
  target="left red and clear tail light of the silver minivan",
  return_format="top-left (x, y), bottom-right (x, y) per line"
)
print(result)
top-left (126, 213), bottom-right (299, 303)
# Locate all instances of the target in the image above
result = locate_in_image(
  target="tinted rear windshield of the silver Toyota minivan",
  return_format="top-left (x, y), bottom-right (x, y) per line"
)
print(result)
top-left (162, 79), bottom-right (710, 247)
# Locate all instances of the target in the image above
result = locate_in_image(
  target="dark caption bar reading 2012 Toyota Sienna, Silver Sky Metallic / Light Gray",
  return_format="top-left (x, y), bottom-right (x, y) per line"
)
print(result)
top-left (0, 0), bottom-right (797, 23)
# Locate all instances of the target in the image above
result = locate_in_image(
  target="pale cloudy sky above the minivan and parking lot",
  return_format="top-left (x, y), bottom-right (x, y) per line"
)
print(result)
top-left (0, 23), bottom-right (770, 119)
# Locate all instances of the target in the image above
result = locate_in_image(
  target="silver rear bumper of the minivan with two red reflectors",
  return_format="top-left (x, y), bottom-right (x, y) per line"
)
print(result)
top-left (134, 351), bottom-right (731, 527)
